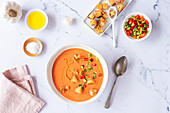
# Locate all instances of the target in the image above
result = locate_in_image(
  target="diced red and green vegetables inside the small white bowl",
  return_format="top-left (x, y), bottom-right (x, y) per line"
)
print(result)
top-left (124, 15), bottom-right (150, 39)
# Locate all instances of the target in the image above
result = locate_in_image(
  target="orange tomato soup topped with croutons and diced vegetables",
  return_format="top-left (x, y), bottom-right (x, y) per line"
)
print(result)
top-left (52, 48), bottom-right (104, 102)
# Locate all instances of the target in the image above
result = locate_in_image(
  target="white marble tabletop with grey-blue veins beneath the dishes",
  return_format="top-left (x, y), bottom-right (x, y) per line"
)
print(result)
top-left (0, 0), bottom-right (170, 113)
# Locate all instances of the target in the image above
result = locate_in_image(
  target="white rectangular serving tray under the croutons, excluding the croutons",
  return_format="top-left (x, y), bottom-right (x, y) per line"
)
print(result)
top-left (83, 0), bottom-right (132, 36)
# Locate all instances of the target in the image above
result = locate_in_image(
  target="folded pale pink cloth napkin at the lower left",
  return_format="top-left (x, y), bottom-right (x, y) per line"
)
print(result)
top-left (0, 66), bottom-right (45, 113)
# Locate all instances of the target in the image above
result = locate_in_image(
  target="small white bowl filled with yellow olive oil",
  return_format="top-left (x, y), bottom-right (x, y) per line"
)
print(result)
top-left (25, 9), bottom-right (48, 31)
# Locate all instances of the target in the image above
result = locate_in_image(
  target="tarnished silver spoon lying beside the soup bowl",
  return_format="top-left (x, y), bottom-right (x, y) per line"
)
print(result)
top-left (104, 56), bottom-right (128, 109)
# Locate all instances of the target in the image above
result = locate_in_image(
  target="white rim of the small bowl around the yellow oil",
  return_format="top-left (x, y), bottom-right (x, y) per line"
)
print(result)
top-left (25, 9), bottom-right (48, 31)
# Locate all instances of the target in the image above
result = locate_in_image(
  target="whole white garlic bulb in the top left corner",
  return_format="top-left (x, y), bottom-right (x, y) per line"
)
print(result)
top-left (0, 1), bottom-right (22, 23)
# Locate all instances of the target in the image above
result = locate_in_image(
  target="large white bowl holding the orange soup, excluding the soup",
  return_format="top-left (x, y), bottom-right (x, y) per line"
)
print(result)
top-left (47, 44), bottom-right (108, 104)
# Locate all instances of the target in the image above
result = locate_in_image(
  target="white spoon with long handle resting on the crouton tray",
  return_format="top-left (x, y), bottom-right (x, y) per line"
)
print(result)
top-left (108, 6), bottom-right (118, 48)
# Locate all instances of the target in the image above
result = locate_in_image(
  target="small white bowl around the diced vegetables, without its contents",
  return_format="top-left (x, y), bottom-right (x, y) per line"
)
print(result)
top-left (122, 12), bottom-right (152, 41)
